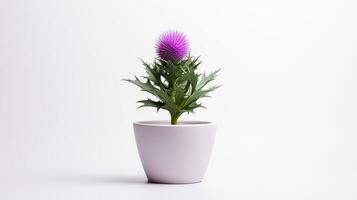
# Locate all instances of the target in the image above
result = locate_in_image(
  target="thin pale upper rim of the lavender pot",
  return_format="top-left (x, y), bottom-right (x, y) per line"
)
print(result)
top-left (133, 120), bottom-right (216, 127)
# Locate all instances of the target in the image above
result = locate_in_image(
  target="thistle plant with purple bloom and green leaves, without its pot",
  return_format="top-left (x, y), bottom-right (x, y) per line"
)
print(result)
top-left (125, 31), bottom-right (219, 125)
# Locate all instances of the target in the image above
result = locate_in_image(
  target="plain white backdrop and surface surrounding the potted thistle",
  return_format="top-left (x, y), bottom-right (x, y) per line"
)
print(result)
top-left (0, 0), bottom-right (357, 200)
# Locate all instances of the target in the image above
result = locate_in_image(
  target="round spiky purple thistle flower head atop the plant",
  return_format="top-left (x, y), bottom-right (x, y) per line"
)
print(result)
top-left (156, 31), bottom-right (188, 61)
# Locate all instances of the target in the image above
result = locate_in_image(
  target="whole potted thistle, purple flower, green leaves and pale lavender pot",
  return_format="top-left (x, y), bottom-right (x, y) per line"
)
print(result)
top-left (125, 31), bottom-right (219, 183)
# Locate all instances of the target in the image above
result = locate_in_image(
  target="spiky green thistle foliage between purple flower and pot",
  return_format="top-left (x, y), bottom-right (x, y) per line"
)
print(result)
top-left (125, 56), bottom-right (219, 123)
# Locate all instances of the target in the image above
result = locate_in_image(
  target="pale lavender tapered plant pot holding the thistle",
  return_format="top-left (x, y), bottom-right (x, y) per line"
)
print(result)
top-left (134, 121), bottom-right (216, 184)
